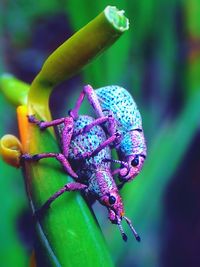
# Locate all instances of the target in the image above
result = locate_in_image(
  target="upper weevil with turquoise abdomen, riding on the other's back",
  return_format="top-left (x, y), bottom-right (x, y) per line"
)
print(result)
top-left (70, 85), bottom-right (147, 185)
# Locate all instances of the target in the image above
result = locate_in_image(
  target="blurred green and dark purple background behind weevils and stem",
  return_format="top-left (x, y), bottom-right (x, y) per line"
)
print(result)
top-left (0, 0), bottom-right (200, 267)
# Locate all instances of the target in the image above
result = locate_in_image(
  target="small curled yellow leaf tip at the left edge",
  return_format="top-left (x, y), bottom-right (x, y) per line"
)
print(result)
top-left (0, 134), bottom-right (22, 168)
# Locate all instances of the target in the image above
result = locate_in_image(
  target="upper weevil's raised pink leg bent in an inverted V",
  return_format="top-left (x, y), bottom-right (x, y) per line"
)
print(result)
top-left (70, 85), bottom-right (104, 119)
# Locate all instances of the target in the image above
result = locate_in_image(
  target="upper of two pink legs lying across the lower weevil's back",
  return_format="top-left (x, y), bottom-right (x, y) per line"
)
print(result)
top-left (73, 116), bottom-right (116, 137)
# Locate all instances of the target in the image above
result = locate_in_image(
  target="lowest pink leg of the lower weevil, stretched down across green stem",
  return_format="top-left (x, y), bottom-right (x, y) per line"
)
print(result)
top-left (35, 182), bottom-right (88, 218)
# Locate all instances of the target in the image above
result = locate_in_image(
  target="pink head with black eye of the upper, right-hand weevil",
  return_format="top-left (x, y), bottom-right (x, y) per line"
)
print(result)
top-left (119, 155), bottom-right (145, 182)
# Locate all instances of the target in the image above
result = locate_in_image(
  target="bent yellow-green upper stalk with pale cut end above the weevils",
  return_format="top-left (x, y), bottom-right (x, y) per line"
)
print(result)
top-left (28, 6), bottom-right (129, 120)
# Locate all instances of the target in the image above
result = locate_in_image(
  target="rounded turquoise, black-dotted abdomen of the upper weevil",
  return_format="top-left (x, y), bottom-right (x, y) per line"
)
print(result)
top-left (95, 85), bottom-right (142, 134)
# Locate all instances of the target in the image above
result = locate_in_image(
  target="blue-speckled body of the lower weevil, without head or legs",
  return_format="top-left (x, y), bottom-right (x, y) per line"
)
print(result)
top-left (58, 115), bottom-right (117, 197)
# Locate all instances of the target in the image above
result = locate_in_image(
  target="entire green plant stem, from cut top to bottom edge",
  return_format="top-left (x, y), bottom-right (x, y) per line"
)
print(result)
top-left (21, 7), bottom-right (128, 267)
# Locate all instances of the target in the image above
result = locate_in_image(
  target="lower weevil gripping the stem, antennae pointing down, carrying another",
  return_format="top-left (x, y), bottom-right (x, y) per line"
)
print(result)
top-left (22, 115), bottom-right (140, 241)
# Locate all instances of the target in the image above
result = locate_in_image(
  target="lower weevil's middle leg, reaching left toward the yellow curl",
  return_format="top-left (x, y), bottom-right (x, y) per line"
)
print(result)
top-left (21, 153), bottom-right (78, 179)
